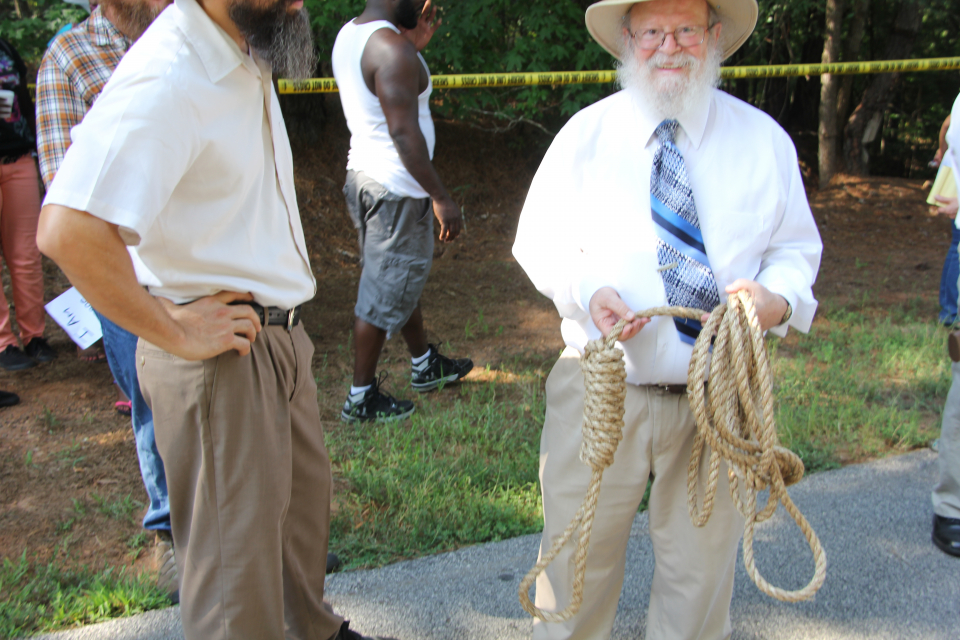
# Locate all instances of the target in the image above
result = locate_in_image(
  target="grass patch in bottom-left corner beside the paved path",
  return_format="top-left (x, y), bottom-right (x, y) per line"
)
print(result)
top-left (0, 551), bottom-right (170, 638)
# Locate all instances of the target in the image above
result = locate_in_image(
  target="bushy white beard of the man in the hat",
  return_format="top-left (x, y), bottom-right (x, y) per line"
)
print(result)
top-left (617, 38), bottom-right (723, 120)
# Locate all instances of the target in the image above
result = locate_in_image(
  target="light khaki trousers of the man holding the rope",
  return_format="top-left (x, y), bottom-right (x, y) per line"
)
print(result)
top-left (533, 347), bottom-right (743, 640)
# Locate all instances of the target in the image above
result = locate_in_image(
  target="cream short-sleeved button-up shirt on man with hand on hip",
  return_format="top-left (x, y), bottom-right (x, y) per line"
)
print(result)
top-left (45, 0), bottom-right (316, 308)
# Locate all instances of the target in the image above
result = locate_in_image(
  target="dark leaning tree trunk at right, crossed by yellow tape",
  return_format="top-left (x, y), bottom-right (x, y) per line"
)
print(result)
top-left (843, 0), bottom-right (920, 176)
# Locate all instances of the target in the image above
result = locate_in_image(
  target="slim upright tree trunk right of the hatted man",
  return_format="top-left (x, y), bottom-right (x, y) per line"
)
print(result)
top-left (817, 0), bottom-right (845, 187)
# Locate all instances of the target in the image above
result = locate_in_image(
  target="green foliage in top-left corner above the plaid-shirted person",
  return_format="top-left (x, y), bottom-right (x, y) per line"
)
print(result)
top-left (0, 0), bottom-right (87, 65)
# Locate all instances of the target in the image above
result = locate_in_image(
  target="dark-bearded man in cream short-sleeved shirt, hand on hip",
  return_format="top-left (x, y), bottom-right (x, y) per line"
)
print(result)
top-left (37, 0), bottom-right (390, 640)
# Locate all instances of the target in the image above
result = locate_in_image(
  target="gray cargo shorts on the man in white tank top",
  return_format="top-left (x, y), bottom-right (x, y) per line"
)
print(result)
top-left (343, 171), bottom-right (433, 337)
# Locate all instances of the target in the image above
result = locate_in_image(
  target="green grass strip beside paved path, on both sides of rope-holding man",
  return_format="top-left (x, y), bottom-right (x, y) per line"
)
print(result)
top-left (327, 304), bottom-right (950, 569)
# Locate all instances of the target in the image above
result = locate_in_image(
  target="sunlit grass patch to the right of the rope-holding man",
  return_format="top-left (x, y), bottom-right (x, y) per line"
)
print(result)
top-left (767, 307), bottom-right (950, 471)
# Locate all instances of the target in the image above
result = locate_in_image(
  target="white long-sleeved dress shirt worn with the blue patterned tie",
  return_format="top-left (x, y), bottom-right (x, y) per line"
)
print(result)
top-left (513, 91), bottom-right (823, 384)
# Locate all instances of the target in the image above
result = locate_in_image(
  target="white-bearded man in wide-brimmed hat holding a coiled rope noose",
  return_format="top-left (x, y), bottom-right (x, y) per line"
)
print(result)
top-left (513, 0), bottom-right (822, 640)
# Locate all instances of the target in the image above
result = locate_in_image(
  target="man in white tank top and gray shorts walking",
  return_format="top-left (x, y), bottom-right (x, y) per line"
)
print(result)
top-left (332, 0), bottom-right (473, 422)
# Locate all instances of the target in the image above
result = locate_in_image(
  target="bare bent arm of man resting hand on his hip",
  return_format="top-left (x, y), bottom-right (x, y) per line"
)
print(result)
top-left (37, 204), bottom-right (261, 360)
